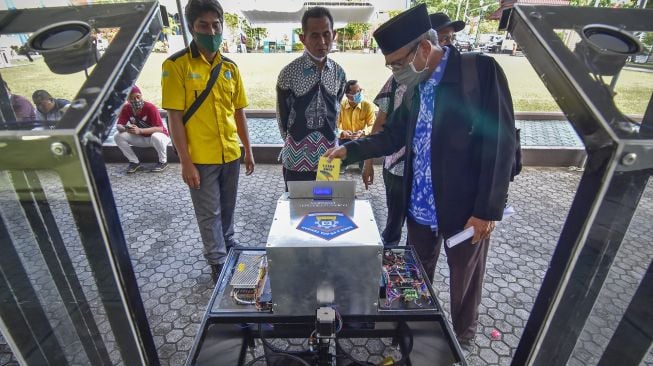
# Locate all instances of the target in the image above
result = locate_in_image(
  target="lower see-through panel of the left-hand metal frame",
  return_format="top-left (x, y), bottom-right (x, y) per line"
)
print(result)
top-left (0, 171), bottom-right (122, 365)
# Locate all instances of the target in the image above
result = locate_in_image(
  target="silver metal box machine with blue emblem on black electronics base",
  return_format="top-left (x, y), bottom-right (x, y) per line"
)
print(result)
top-left (187, 181), bottom-right (466, 366)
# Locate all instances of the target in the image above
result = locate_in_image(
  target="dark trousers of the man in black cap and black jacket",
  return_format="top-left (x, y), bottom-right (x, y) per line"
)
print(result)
top-left (407, 217), bottom-right (490, 338)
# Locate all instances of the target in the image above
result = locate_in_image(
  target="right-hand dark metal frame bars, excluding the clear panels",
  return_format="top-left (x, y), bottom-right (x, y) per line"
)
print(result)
top-left (508, 5), bottom-right (653, 365)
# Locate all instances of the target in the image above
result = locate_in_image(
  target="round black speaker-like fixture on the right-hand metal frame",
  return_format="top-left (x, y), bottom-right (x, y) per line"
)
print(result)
top-left (574, 24), bottom-right (642, 76)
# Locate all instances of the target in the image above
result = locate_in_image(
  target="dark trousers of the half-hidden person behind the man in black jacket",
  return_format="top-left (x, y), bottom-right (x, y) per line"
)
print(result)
top-left (381, 168), bottom-right (406, 245)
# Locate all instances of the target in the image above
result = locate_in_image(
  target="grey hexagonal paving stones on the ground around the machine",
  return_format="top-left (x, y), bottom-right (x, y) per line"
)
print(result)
top-left (0, 164), bottom-right (653, 365)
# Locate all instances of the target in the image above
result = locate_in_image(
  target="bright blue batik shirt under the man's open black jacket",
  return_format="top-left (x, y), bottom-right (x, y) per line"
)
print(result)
top-left (408, 48), bottom-right (449, 230)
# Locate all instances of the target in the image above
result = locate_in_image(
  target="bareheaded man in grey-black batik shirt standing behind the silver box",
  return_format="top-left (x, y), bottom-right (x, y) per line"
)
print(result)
top-left (277, 6), bottom-right (347, 190)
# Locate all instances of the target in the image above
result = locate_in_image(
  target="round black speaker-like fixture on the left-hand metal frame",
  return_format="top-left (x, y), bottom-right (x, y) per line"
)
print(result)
top-left (27, 21), bottom-right (97, 74)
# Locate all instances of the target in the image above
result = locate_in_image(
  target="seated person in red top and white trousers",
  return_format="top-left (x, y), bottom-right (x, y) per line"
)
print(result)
top-left (113, 85), bottom-right (170, 174)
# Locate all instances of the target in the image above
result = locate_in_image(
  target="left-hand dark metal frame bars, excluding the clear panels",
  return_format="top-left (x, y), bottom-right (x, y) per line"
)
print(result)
top-left (0, 2), bottom-right (162, 365)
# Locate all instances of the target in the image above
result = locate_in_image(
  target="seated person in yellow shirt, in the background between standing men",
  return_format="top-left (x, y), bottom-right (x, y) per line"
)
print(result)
top-left (337, 80), bottom-right (374, 169)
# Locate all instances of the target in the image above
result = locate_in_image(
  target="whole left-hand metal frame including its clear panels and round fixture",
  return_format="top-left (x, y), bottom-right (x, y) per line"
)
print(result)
top-left (0, 0), bottom-right (161, 365)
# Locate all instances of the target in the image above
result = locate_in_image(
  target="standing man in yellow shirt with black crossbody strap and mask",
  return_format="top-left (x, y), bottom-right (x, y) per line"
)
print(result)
top-left (161, 0), bottom-right (254, 282)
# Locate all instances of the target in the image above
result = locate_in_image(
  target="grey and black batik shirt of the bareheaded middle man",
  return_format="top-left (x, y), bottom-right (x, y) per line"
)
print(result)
top-left (277, 54), bottom-right (347, 171)
